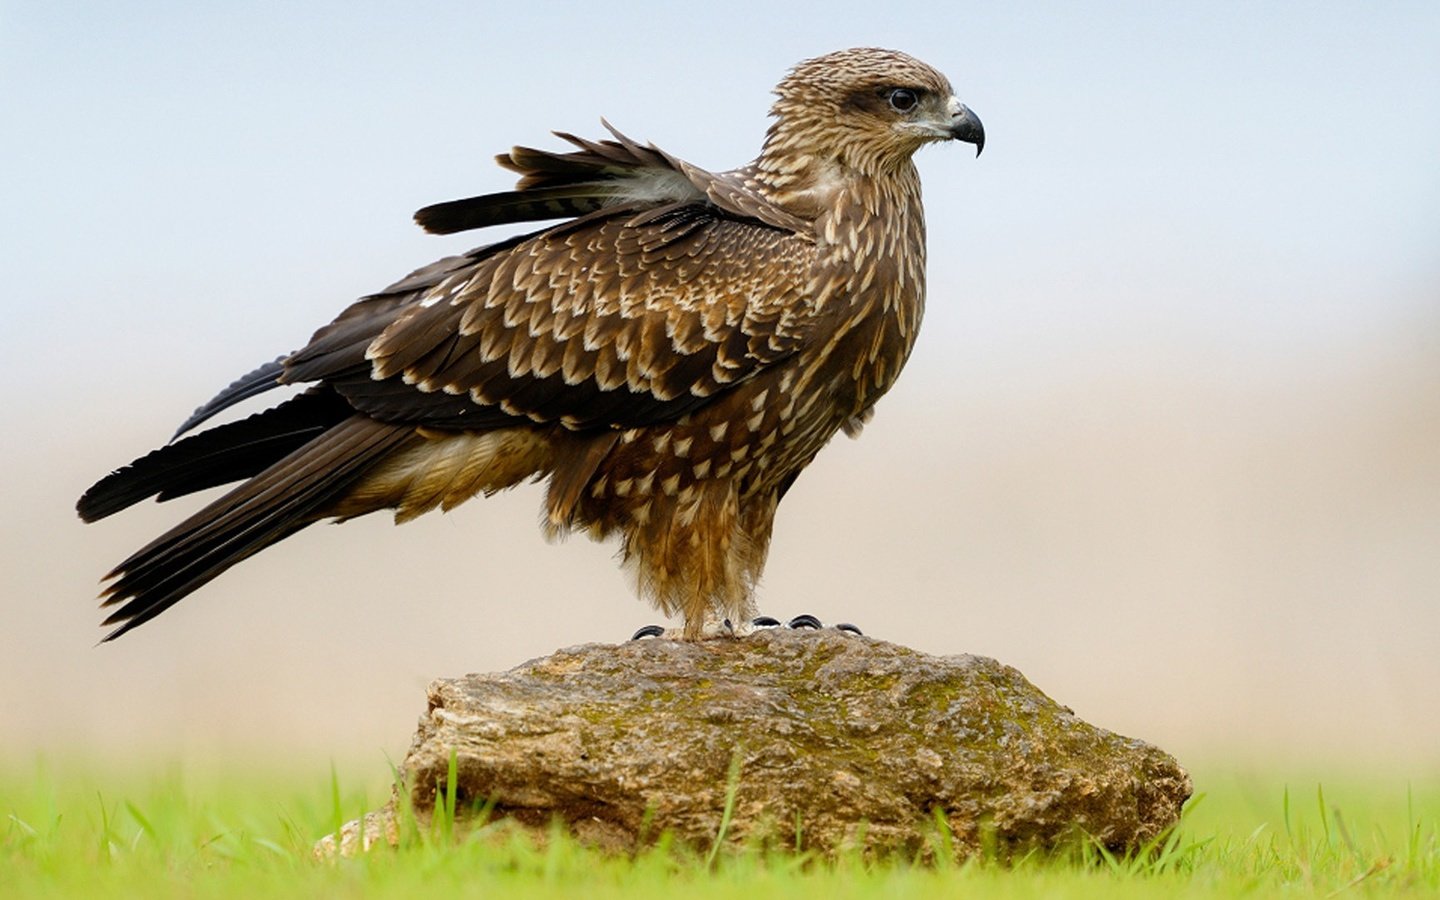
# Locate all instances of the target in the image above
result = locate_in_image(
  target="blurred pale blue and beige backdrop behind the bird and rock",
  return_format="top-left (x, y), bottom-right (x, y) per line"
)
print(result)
top-left (0, 0), bottom-right (1440, 776)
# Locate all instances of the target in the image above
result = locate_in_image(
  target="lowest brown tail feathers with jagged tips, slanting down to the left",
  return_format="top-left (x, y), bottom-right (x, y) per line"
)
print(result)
top-left (94, 416), bottom-right (413, 641)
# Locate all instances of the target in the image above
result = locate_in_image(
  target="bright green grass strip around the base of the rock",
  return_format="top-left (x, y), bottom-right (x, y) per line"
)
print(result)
top-left (0, 760), bottom-right (1440, 900)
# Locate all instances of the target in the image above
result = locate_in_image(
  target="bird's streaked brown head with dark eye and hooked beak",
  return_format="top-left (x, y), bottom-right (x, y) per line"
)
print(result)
top-left (762, 48), bottom-right (985, 174)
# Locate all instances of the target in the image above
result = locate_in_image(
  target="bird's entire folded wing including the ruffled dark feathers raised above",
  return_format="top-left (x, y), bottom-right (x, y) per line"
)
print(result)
top-left (227, 124), bottom-right (827, 431)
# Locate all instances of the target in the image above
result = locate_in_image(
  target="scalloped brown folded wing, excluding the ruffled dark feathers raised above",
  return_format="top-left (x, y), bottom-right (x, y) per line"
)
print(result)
top-left (284, 200), bottom-right (819, 429)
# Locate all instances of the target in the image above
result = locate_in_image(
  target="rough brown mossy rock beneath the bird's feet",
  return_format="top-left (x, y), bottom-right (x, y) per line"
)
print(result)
top-left (326, 629), bottom-right (1191, 858)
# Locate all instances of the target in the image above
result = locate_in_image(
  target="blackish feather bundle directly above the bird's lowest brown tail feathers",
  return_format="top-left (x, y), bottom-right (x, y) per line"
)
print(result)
top-left (75, 390), bottom-right (353, 521)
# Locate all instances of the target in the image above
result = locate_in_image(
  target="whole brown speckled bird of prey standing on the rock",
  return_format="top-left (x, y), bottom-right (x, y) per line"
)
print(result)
top-left (78, 49), bottom-right (985, 641)
